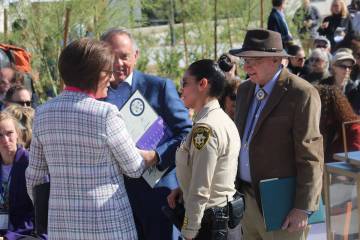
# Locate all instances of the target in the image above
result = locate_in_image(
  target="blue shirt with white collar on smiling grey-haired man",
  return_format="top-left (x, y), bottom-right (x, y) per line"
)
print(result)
top-left (106, 72), bottom-right (134, 109)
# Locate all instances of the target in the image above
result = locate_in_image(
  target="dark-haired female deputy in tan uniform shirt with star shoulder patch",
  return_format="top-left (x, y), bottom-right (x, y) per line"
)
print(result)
top-left (176, 59), bottom-right (240, 240)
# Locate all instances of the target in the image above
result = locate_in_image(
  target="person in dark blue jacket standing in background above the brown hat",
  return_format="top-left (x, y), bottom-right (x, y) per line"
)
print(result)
top-left (268, 0), bottom-right (292, 48)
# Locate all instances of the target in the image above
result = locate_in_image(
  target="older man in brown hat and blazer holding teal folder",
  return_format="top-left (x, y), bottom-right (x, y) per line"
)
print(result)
top-left (230, 29), bottom-right (324, 240)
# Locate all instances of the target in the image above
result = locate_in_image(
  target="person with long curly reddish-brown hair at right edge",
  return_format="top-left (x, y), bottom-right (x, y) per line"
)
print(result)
top-left (315, 85), bottom-right (360, 162)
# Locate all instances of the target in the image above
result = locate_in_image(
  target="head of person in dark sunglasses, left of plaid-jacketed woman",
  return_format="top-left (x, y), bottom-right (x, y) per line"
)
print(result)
top-left (4, 85), bottom-right (32, 107)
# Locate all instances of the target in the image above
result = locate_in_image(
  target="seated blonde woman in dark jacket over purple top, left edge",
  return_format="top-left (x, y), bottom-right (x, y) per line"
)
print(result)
top-left (0, 112), bottom-right (39, 239)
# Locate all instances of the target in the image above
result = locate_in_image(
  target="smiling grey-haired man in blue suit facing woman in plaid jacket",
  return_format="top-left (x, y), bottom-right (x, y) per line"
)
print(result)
top-left (101, 29), bottom-right (191, 240)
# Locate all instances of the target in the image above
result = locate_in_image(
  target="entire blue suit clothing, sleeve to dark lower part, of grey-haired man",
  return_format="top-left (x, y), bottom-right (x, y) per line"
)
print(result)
top-left (105, 71), bottom-right (191, 240)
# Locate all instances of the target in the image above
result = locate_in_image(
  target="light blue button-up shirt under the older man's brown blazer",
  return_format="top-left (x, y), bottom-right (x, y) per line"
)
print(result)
top-left (238, 67), bottom-right (282, 182)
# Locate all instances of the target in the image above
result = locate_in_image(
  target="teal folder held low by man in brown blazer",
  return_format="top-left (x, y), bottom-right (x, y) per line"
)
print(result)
top-left (259, 177), bottom-right (325, 232)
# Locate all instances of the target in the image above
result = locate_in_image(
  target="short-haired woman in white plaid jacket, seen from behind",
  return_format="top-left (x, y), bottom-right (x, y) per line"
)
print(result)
top-left (26, 39), bottom-right (154, 240)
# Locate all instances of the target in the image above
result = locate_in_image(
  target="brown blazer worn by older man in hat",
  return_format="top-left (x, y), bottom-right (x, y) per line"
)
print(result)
top-left (235, 68), bottom-right (324, 211)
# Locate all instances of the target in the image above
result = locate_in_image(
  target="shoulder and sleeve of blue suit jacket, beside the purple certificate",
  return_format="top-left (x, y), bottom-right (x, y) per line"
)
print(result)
top-left (120, 71), bottom-right (192, 171)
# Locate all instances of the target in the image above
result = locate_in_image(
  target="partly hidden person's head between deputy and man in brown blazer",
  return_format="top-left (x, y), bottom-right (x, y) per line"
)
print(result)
top-left (219, 80), bottom-right (240, 120)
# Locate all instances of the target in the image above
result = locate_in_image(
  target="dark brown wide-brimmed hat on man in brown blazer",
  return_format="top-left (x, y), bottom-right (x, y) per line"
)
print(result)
top-left (229, 29), bottom-right (291, 57)
